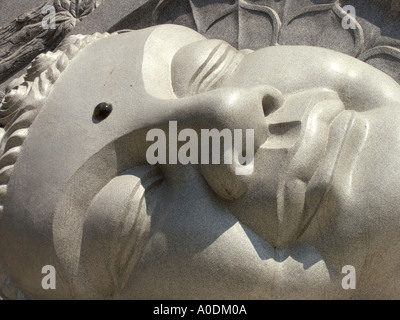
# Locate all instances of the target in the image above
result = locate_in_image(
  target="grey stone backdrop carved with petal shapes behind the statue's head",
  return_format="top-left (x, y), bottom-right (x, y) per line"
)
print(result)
top-left (0, 0), bottom-right (400, 91)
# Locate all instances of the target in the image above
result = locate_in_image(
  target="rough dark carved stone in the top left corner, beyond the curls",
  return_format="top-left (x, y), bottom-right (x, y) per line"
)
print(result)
top-left (0, 0), bottom-right (100, 89)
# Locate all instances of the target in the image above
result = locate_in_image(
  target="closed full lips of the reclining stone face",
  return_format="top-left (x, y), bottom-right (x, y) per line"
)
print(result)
top-left (277, 102), bottom-right (356, 247)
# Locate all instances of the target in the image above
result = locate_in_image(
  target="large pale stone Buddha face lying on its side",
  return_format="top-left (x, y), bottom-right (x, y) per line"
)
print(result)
top-left (0, 25), bottom-right (400, 299)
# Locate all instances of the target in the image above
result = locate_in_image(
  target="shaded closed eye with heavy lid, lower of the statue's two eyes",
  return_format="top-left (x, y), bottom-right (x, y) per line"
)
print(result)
top-left (80, 165), bottom-right (162, 297)
